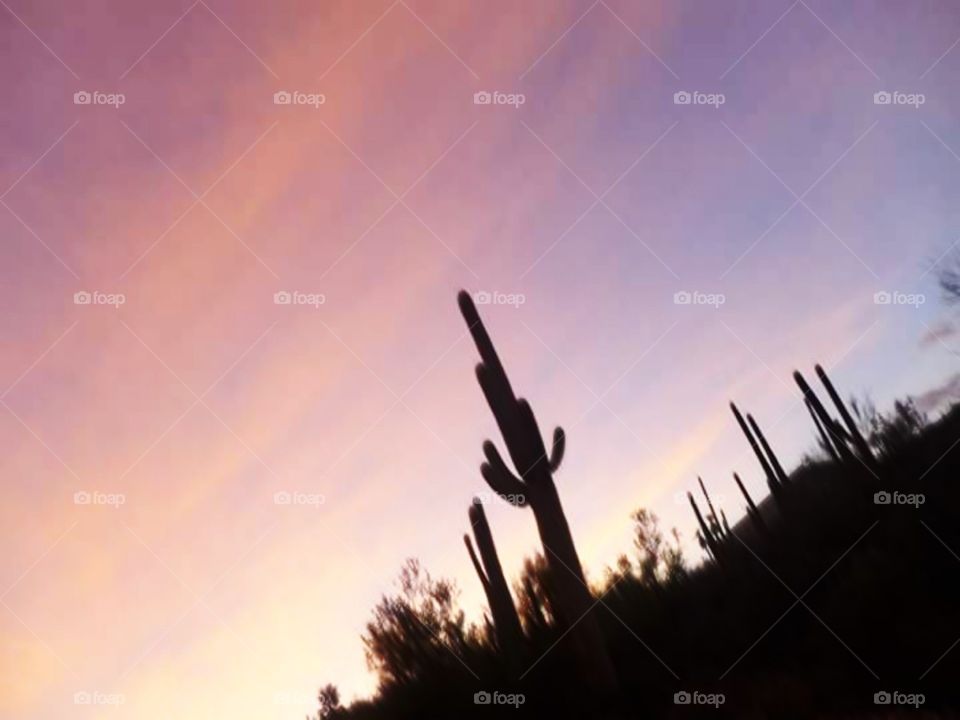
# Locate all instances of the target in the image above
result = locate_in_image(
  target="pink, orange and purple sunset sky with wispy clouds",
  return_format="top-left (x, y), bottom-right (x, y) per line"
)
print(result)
top-left (0, 0), bottom-right (960, 720)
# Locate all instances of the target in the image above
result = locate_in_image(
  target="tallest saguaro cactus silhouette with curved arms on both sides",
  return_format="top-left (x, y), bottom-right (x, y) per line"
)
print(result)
top-left (457, 290), bottom-right (617, 693)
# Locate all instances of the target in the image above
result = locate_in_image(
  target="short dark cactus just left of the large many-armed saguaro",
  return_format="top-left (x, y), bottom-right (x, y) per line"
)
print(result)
top-left (463, 498), bottom-right (523, 659)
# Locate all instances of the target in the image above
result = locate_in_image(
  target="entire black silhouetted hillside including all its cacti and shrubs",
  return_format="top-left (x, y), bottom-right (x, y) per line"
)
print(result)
top-left (319, 297), bottom-right (960, 720)
